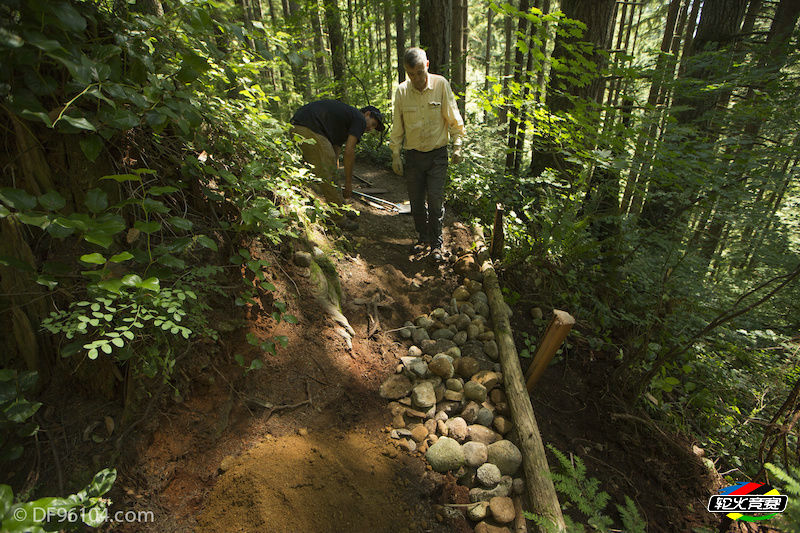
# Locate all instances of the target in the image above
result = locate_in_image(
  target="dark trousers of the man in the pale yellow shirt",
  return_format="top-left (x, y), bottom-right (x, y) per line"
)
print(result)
top-left (405, 146), bottom-right (447, 248)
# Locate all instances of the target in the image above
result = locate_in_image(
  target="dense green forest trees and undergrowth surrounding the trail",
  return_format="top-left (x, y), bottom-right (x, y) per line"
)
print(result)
top-left (0, 0), bottom-right (800, 528)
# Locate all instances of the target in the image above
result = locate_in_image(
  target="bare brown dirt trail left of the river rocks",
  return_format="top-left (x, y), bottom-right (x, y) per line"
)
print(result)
top-left (116, 162), bottom-right (468, 532)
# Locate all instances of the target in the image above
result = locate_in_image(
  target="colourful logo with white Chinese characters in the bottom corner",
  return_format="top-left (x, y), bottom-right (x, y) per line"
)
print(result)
top-left (708, 481), bottom-right (789, 522)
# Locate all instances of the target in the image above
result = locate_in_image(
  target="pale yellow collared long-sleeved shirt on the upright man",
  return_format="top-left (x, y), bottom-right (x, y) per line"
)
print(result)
top-left (389, 73), bottom-right (464, 155)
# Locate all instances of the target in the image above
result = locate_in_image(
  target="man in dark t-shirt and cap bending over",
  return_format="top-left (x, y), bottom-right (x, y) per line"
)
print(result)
top-left (290, 100), bottom-right (385, 204)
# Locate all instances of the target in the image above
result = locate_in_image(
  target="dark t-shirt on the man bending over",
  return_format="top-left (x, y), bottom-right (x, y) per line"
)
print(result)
top-left (290, 100), bottom-right (367, 146)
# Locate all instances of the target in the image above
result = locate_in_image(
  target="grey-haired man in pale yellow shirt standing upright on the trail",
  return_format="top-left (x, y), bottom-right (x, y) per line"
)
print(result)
top-left (389, 48), bottom-right (464, 261)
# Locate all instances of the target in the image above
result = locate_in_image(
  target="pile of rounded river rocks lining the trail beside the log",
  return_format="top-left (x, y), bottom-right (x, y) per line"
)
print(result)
top-left (380, 272), bottom-right (524, 531)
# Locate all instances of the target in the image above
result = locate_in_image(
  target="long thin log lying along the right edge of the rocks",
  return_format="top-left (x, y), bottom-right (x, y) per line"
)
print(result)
top-left (481, 261), bottom-right (567, 533)
